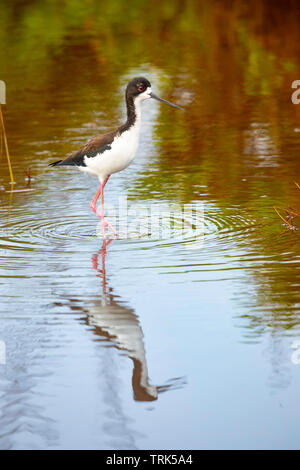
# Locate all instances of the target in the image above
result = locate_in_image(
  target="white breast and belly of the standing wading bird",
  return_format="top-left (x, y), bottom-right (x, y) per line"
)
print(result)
top-left (80, 122), bottom-right (140, 181)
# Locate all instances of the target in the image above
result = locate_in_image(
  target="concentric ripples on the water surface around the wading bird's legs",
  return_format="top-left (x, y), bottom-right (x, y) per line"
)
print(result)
top-left (0, 203), bottom-right (260, 255)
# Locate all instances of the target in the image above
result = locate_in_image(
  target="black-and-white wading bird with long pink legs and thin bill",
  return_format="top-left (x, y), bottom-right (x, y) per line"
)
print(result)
top-left (49, 77), bottom-right (183, 239)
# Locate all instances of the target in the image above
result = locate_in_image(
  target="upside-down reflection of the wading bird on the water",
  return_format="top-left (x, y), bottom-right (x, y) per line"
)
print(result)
top-left (87, 239), bottom-right (183, 401)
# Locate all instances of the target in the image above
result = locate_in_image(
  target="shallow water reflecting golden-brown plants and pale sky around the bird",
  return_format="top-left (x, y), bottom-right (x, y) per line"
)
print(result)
top-left (0, 1), bottom-right (300, 449)
